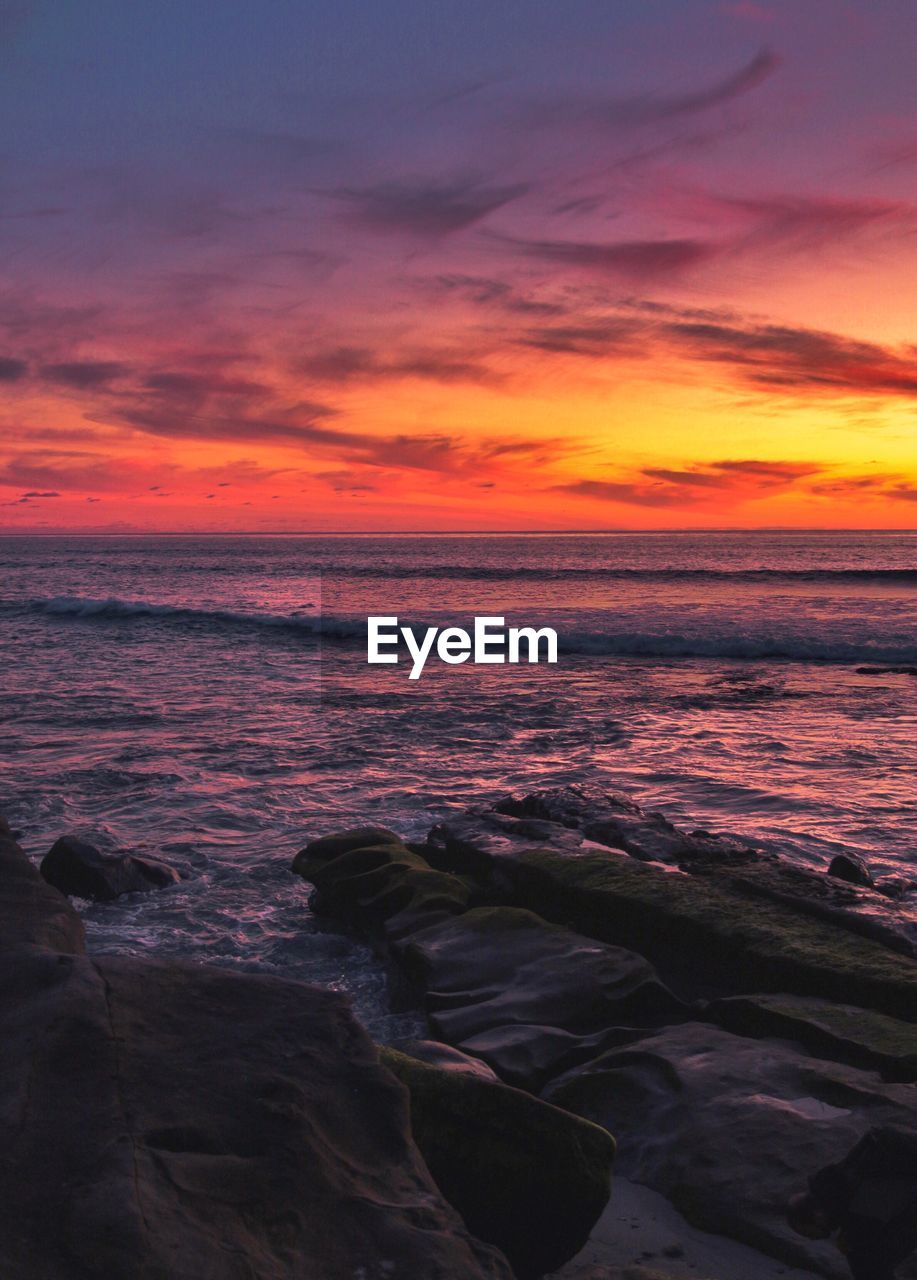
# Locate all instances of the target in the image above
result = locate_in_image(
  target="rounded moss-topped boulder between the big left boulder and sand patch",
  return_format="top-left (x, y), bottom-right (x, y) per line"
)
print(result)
top-left (379, 1048), bottom-right (615, 1280)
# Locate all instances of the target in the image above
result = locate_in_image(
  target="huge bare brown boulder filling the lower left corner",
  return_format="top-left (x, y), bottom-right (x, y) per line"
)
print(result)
top-left (0, 819), bottom-right (512, 1280)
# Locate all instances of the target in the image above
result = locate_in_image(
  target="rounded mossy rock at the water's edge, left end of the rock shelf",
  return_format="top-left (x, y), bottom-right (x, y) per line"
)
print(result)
top-left (293, 828), bottom-right (470, 941)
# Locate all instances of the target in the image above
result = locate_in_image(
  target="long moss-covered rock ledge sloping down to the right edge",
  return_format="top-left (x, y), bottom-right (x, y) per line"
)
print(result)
top-left (503, 850), bottom-right (917, 1019)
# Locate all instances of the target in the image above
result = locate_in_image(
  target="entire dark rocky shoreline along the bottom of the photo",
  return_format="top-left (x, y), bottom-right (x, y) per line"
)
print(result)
top-left (0, 787), bottom-right (917, 1280)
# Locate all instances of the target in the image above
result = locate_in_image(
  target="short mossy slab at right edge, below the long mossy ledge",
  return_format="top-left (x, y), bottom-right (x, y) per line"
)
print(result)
top-left (708, 996), bottom-right (917, 1083)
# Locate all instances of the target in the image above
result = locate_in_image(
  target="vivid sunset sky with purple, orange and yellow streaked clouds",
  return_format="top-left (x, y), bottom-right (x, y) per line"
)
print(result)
top-left (0, 0), bottom-right (917, 532)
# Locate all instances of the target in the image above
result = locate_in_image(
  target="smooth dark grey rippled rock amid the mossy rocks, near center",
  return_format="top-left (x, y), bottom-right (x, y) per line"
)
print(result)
top-left (397, 908), bottom-right (685, 1091)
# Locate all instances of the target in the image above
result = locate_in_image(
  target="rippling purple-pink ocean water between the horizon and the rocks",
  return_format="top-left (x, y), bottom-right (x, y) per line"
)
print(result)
top-left (0, 532), bottom-right (917, 1036)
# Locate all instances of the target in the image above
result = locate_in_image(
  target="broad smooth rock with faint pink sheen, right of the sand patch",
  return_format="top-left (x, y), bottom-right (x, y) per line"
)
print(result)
top-left (546, 1023), bottom-right (917, 1275)
